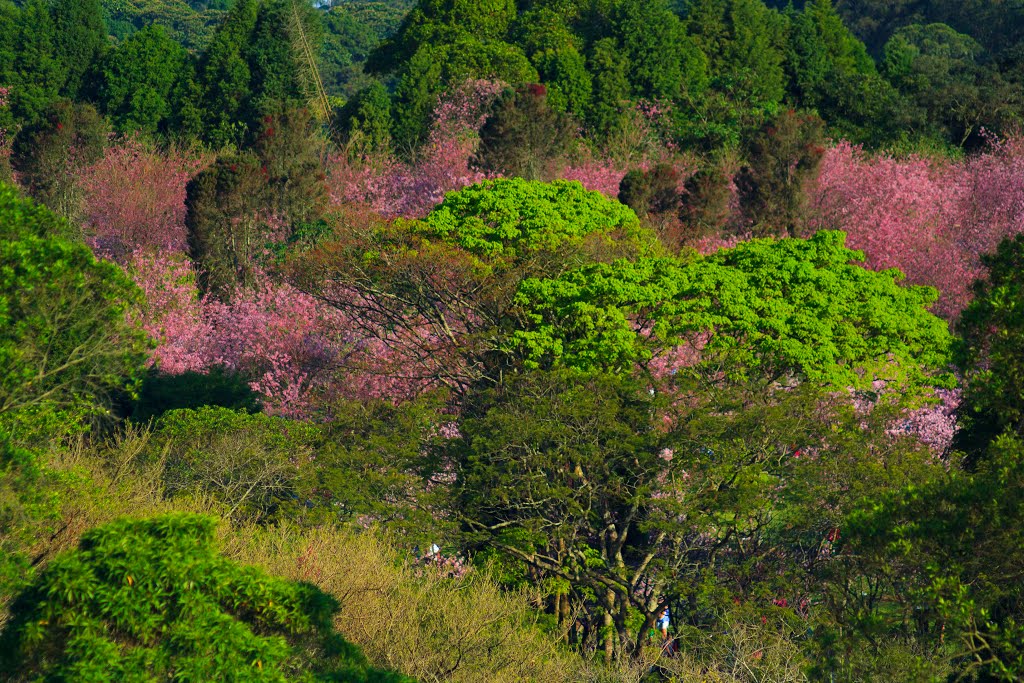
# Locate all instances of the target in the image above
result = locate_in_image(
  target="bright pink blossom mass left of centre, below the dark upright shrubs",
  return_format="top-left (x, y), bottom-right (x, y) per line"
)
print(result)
top-left (130, 250), bottom-right (448, 417)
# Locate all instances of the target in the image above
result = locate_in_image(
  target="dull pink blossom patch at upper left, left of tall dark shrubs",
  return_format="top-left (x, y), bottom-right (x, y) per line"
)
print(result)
top-left (78, 137), bottom-right (208, 260)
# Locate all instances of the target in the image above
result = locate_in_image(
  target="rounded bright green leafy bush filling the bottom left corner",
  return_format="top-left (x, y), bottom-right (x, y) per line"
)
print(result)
top-left (0, 515), bottom-right (409, 683)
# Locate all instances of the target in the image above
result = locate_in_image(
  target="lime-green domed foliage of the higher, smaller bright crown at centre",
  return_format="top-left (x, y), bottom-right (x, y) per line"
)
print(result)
top-left (415, 178), bottom-right (650, 260)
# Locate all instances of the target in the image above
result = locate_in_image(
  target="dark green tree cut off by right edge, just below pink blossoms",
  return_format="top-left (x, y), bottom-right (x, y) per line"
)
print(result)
top-left (955, 237), bottom-right (1024, 450)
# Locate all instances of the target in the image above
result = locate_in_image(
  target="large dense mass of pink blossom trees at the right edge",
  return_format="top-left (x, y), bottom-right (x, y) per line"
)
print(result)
top-left (810, 138), bottom-right (1024, 319)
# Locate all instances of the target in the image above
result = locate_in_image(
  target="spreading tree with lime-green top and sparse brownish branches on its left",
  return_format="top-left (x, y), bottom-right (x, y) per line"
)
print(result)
top-left (287, 178), bottom-right (657, 393)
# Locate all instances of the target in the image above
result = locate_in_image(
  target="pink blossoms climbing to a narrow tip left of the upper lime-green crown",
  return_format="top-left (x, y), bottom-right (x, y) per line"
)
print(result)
top-left (329, 80), bottom-right (506, 218)
